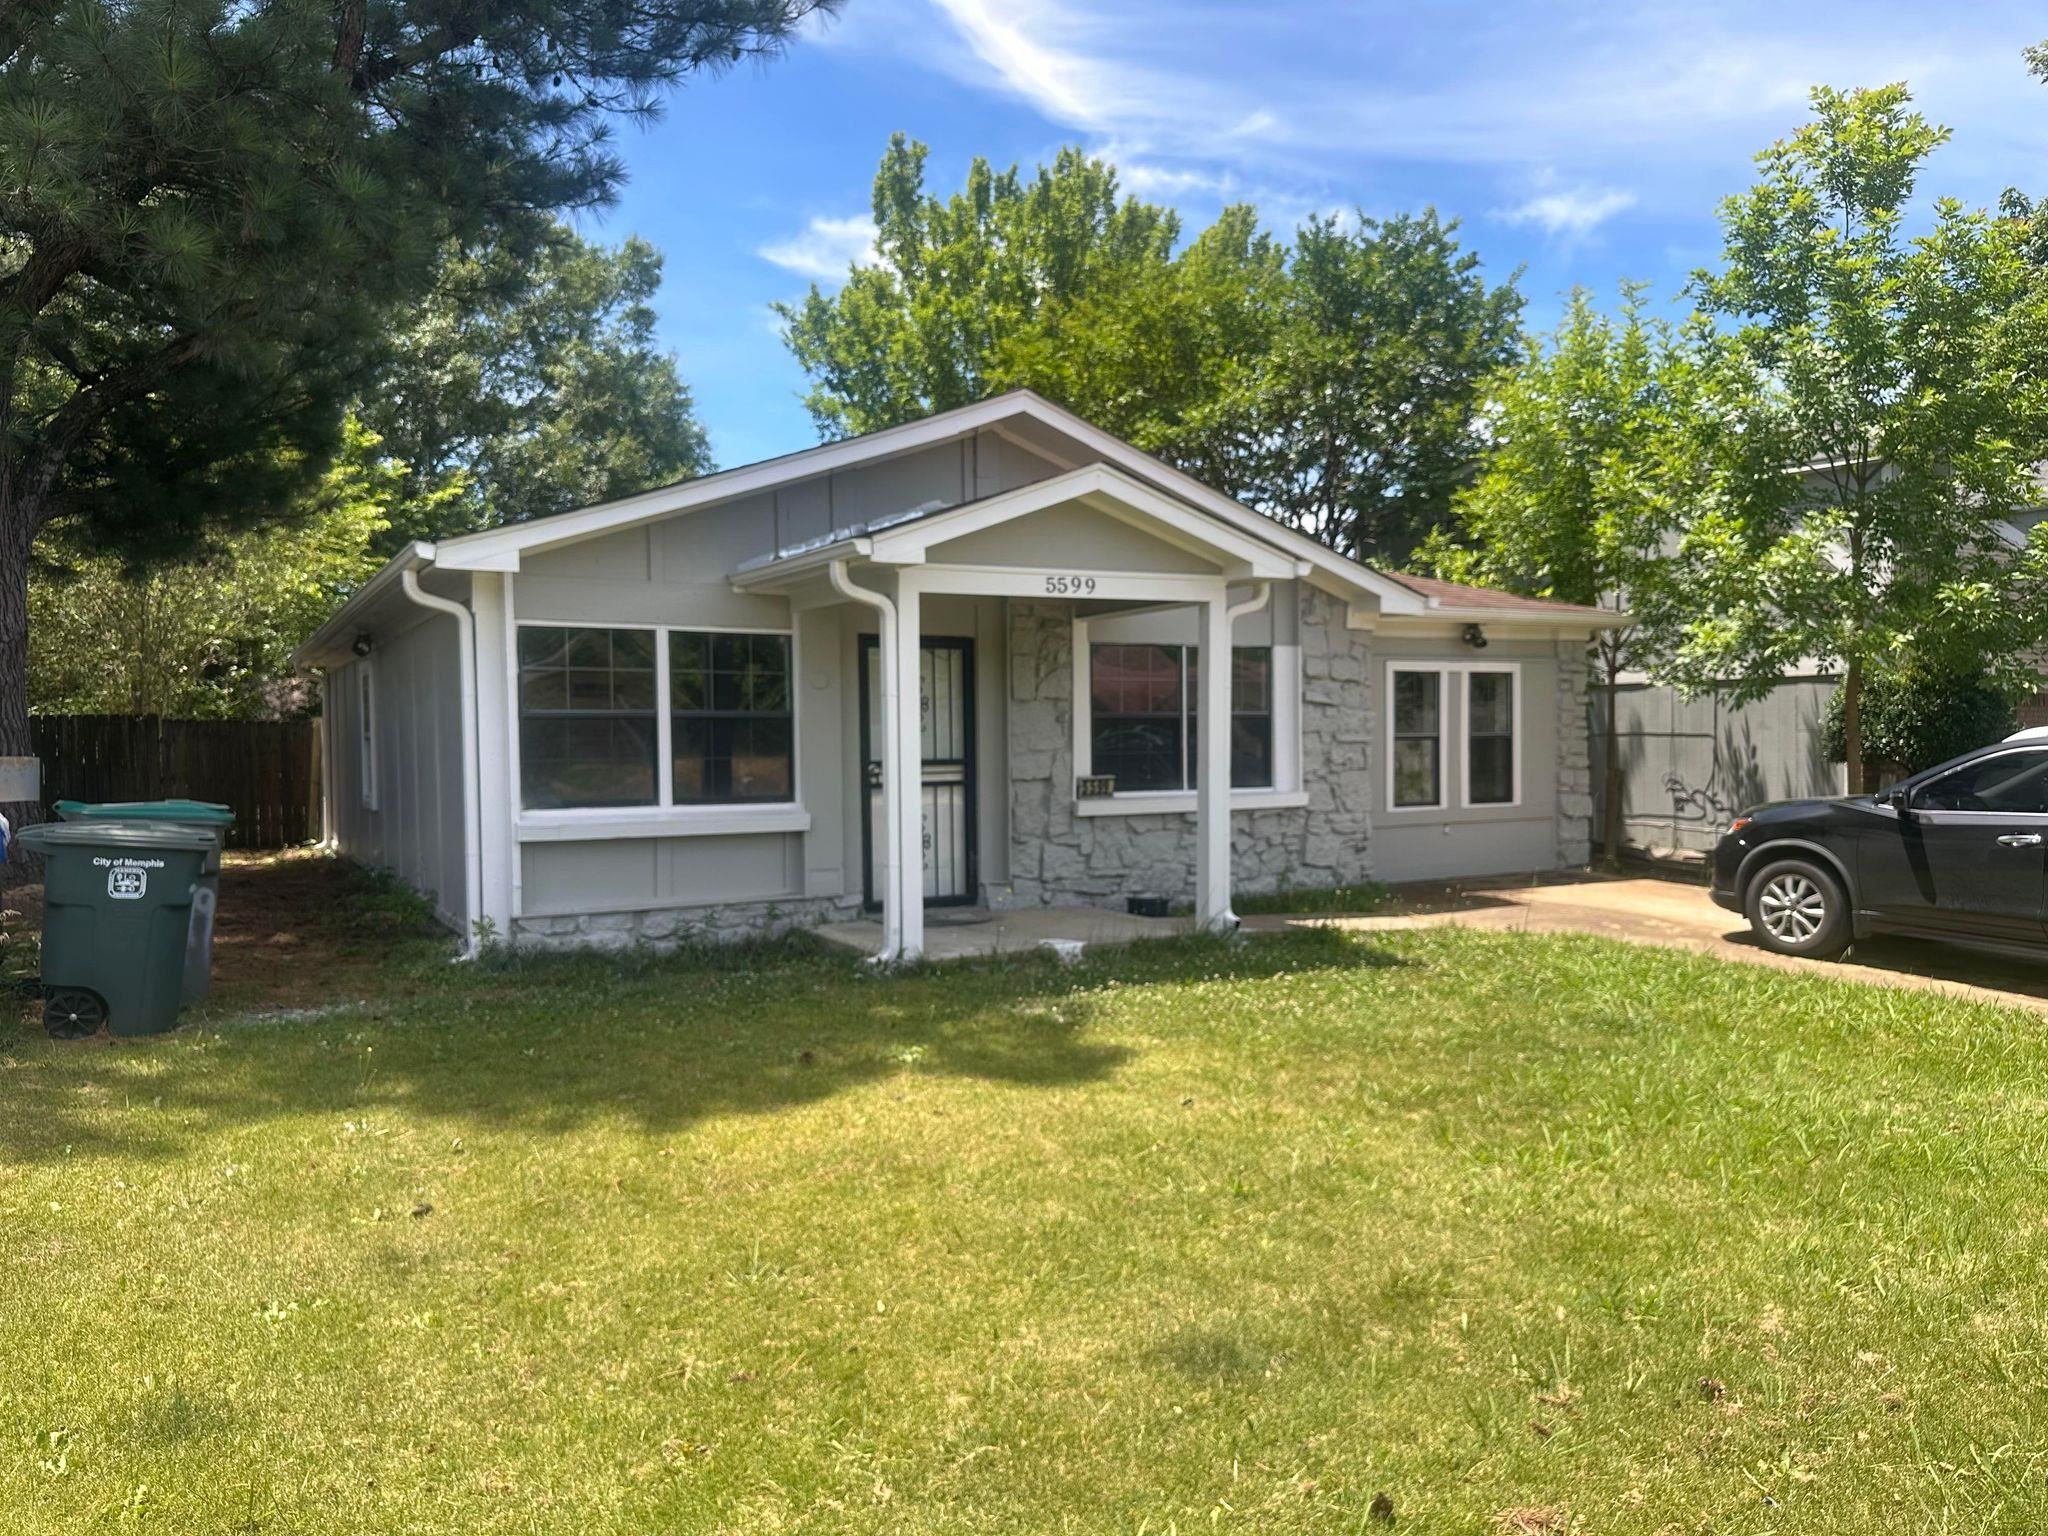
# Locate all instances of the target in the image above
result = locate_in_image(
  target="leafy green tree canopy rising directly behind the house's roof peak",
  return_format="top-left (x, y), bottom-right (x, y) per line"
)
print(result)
top-left (782, 135), bottom-right (1522, 557)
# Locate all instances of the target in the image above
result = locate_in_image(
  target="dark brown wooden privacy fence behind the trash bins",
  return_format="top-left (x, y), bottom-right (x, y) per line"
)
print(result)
top-left (29, 715), bottom-right (319, 848)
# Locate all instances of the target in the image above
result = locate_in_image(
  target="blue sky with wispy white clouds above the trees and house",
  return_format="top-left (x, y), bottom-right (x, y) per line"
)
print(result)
top-left (586, 0), bottom-right (2048, 465)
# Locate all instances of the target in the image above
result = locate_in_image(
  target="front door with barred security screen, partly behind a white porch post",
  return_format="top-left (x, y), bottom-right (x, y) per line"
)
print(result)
top-left (860, 635), bottom-right (975, 907)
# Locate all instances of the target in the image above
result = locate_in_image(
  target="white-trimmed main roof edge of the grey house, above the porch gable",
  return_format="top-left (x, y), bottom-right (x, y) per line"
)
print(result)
top-left (295, 389), bottom-right (1620, 666)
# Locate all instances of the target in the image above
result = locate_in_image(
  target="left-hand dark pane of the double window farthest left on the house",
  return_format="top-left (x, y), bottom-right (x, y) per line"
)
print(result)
top-left (518, 625), bottom-right (657, 811)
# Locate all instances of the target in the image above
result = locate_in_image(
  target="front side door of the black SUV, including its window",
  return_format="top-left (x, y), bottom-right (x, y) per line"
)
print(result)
top-left (1855, 748), bottom-right (2048, 944)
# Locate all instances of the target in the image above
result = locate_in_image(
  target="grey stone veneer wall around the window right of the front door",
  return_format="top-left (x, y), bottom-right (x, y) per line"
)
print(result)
top-left (987, 582), bottom-right (1376, 907)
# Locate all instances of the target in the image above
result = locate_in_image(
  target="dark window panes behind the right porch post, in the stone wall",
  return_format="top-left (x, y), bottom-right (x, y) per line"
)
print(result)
top-left (1087, 645), bottom-right (1274, 795)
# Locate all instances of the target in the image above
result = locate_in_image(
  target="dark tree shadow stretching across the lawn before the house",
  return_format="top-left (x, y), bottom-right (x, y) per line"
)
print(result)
top-left (0, 901), bottom-right (1395, 1163)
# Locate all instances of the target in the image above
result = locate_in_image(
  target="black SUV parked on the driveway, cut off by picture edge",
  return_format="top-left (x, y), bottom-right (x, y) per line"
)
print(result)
top-left (1714, 737), bottom-right (2048, 958)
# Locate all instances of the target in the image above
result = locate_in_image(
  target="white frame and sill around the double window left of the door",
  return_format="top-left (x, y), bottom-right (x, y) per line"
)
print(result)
top-left (506, 618), bottom-right (811, 842)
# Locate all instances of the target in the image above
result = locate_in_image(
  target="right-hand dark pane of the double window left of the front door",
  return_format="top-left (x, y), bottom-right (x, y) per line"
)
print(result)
top-left (668, 629), bottom-right (797, 805)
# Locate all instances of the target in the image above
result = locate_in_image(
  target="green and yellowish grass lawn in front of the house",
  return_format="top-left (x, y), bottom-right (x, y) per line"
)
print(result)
top-left (0, 860), bottom-right (2048, 1536)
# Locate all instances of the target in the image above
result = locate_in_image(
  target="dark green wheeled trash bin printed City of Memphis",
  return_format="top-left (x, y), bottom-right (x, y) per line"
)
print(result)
top-left (16, 821), bottom-right (213, 1036)
